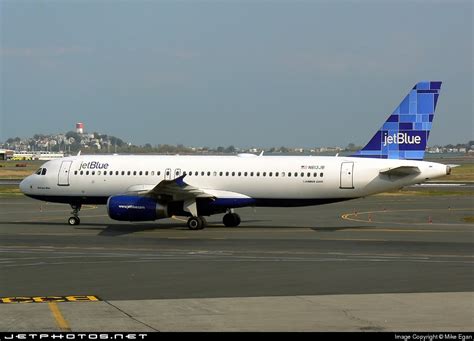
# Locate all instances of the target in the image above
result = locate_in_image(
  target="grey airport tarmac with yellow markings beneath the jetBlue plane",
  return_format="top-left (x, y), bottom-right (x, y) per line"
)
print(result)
top-left (0, 195), bottom-right (474, 332)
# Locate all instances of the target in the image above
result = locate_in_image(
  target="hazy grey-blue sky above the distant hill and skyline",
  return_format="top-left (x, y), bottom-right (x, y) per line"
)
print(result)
top-left (0, 0), bottom-right (474, 147)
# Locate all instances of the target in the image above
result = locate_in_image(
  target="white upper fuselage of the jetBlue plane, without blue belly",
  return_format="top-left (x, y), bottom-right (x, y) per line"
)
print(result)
top-left (20, 155), bottom-right (447, 206)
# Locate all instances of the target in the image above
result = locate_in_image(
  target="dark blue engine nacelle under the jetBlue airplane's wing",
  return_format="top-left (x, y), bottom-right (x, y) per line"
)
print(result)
top-left (107, 195), bottom-right (169, 221)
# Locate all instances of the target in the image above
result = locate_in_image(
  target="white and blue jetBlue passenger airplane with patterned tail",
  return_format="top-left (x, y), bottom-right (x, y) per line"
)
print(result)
top-left (20, 81), bottom-right (451, 230)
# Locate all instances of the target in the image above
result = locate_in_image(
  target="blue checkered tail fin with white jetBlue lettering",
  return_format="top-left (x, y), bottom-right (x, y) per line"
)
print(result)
top-left (351, 81), bottom-right (441, 160)
